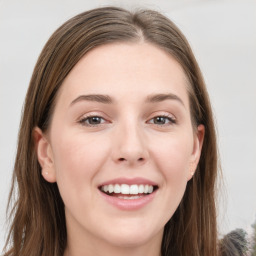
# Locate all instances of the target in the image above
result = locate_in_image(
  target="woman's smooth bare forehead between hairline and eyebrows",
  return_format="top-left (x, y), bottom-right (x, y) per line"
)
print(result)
top-left (56, 43), bottom-right (188, 107)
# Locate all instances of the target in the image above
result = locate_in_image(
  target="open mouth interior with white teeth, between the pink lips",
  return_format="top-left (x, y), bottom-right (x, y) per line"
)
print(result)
top-left (99, 184), bottom-right (158, 200)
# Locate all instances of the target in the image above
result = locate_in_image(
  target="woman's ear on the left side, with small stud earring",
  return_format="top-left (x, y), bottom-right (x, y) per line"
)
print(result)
top-left (33, 127), bottom-right (56, 183)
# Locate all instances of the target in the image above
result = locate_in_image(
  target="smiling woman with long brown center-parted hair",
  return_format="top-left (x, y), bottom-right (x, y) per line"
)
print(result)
top-left (2, 7), bottom-right (241, 256)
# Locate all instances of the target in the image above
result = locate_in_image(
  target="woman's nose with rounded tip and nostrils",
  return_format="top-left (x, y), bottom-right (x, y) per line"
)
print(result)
top-left (112, 122), bottom-right (149, 165)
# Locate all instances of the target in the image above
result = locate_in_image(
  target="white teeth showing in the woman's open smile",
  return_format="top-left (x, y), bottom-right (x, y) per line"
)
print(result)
top-left (100, 184), bottom-right (154, 195)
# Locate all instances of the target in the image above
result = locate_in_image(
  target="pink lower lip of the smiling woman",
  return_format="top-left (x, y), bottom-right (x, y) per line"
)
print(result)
top-left (100, 191), bottom-right (156, 211)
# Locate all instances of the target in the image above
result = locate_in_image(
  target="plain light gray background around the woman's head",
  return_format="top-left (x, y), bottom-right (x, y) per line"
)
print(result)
top-left (0, 0), bottom-right (256, 250)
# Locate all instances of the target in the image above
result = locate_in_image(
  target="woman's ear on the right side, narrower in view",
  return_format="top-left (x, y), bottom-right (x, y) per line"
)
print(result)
top-left (188, 124), bottom-right (205, 180)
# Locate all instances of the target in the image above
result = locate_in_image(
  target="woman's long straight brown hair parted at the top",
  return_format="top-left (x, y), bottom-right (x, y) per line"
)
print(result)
top-left (5, 7), bottom-right (218, 256)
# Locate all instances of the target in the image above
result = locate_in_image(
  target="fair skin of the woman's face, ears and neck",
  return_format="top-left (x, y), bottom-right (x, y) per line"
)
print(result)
top-left (35, 42), bottom-right (204, 256)
